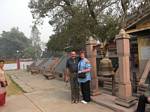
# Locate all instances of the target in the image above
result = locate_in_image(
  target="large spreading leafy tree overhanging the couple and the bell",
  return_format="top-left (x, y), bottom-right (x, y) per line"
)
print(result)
top-left (29, 0), bottom-right (148, 51)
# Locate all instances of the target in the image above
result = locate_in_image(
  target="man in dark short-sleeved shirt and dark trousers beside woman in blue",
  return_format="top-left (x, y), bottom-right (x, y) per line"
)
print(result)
top-left (65, 51), bottom-right (79, 103)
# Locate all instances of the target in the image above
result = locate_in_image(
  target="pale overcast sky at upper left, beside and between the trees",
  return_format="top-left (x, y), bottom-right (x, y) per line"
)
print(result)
top-left (0, 0), bottom-right (53, 42)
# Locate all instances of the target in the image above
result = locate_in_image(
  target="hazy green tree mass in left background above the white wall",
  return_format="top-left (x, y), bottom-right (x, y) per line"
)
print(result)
top-left (0, 28), bottom-right (41, 59)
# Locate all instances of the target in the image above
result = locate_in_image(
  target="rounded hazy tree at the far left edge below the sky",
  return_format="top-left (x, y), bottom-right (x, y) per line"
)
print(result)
top-left (0, 28), bottom-right (31, 58)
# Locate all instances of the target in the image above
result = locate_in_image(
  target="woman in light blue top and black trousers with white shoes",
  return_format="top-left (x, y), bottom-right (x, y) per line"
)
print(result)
top-left (78, 51), bottom-right (91, 104)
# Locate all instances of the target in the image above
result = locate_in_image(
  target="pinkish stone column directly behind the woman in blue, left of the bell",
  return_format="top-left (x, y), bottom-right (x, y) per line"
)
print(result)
top-left (86, 37), bottom-right (100, 96)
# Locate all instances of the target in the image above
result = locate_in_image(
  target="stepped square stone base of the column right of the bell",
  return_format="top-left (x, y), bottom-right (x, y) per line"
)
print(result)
top-left (115, 97), bottom-right (136, 108)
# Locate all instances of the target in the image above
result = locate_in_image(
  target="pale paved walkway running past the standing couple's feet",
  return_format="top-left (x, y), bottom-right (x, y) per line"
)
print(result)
top-left (0, 71), bottom-right (113, 112)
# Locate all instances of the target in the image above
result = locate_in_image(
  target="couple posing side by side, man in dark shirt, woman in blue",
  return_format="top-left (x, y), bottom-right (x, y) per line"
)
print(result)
top-left (65, 51), bottom-right (91, 104)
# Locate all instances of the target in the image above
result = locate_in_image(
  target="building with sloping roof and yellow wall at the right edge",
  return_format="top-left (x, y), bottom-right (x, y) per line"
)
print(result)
top-left (126, 6), bottom-right (150, 91)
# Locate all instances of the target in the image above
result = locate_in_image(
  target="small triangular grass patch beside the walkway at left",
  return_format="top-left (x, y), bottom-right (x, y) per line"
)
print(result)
top-left (6, 74), bottom-right (23, 96)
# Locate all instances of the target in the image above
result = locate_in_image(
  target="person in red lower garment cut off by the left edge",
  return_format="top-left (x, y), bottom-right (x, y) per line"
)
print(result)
top-left (0, 60), bottom-right (7, 106)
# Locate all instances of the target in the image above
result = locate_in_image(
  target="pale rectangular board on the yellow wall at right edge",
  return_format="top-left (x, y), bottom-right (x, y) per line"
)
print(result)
top-left (141, 47), bottom-right (150, 60)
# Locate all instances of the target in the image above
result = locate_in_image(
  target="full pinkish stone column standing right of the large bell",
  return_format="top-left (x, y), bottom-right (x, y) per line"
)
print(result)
top-left (115, 29), bottom-right (135, 107)
